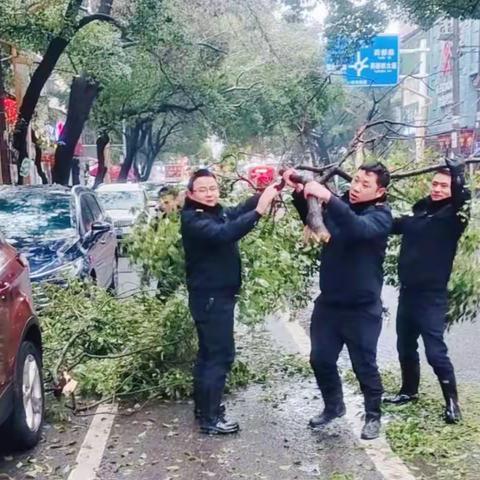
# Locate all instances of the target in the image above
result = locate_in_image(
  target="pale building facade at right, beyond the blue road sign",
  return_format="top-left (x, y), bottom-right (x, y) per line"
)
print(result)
top-left (401, 19), bottom-right (480, 155)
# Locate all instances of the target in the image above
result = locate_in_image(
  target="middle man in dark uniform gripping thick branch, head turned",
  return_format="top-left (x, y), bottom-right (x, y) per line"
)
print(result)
top-left (284, 163), bottom-right (392, 440)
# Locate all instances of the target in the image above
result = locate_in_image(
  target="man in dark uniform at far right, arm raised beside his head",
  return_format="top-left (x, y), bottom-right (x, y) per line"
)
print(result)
top-left (385, 161), bottom-right (470, 423)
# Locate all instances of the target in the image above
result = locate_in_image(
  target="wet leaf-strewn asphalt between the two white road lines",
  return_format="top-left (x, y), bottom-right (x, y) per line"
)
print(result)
top-left (98, 382), bottom-right (382, 480)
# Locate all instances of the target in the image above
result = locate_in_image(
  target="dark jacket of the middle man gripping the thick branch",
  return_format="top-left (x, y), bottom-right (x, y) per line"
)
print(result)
top-left (294, 194), bottom-right (392, 307)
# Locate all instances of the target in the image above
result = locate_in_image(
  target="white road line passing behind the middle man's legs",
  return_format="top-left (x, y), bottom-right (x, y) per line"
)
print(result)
top-left (266, 312), bottom-right (415, 480)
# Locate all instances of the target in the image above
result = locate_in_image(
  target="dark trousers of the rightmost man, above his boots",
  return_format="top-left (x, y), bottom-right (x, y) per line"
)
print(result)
top-left (397, 288), bottom-right (455, 394)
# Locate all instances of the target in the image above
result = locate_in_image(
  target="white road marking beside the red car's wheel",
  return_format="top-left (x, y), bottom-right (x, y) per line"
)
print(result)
top-left (68, 404), bottom-right (118, 480)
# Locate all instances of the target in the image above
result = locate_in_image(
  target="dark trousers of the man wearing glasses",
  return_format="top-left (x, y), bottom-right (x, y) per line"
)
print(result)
top-left (189, 292), bottom-right (236, 422)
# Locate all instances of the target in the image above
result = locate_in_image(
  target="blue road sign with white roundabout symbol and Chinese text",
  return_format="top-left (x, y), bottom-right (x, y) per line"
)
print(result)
top-left (327, 35), bottom-right (400, 87)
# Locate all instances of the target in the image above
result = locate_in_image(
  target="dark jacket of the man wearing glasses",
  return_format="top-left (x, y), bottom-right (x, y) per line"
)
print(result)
top-left (181, 195), bottom-right (260, 295)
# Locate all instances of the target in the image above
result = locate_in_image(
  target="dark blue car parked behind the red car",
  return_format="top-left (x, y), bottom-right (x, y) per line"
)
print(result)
top-left (0, 185), bottom-right (118, 290)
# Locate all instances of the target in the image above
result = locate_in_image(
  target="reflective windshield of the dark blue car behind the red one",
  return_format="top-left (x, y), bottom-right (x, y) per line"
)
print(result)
top-left (0, 189), bottom-right (74, 239)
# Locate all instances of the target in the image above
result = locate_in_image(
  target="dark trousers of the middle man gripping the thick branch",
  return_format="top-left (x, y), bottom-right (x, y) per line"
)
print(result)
top-left (310, 297), bottom-right (383, 419)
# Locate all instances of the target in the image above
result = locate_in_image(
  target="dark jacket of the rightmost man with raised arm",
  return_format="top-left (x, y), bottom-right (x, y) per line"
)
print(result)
top-left (392, 167), bottom-right (470, 290)
